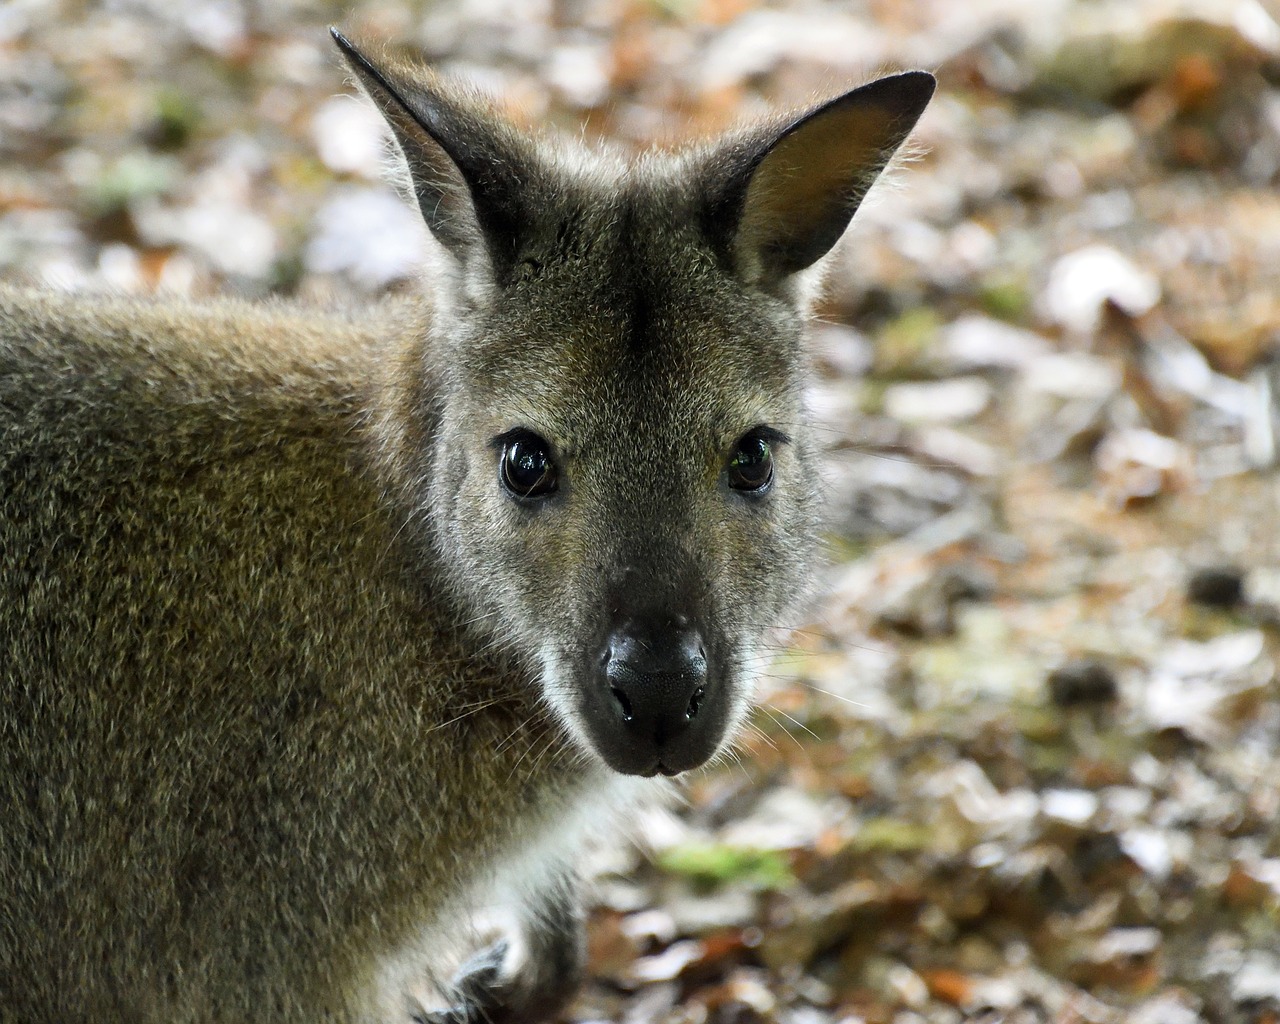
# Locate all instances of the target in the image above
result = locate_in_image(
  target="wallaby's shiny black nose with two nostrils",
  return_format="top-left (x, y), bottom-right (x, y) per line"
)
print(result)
top-left (602, 617), bottom-right (707, 774)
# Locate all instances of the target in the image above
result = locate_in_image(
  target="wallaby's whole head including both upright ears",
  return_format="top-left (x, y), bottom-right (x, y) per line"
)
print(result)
top-left (334, 32), bottom-right (933, 776)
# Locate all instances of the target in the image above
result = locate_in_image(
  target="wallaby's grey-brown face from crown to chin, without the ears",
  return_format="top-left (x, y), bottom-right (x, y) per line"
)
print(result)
top-left (428, 202), bottom-right (814, 774)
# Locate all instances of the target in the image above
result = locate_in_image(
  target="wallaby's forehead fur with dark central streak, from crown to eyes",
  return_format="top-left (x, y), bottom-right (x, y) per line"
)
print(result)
top-left (457, 155), bottom-right (803, 443)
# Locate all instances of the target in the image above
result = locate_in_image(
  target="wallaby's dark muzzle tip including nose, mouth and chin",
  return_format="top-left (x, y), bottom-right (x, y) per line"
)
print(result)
top-left (579, 614), bottom-right (728, 777)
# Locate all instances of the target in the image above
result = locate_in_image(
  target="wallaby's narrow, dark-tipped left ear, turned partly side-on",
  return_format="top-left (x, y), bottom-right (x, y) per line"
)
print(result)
top-left (329, 28), bottom-right (536, 276)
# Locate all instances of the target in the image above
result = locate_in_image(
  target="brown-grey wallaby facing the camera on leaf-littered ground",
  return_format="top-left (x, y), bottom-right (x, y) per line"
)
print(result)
top-left (0, 32), bottom-right (933, 1024)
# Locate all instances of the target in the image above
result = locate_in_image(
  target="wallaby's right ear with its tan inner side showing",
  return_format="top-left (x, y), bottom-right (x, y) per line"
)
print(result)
top-left (712, 72), bottom-right (936, 287)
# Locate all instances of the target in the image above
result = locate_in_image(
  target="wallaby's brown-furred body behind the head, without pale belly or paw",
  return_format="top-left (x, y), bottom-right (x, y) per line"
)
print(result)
top-left (0, 297), bottom-right (588, 1020)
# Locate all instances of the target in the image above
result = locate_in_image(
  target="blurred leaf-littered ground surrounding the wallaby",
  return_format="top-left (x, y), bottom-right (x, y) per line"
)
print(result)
top-left (0, 0), bottom-right (1280, 1024)
